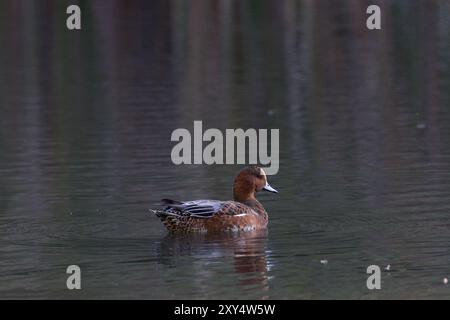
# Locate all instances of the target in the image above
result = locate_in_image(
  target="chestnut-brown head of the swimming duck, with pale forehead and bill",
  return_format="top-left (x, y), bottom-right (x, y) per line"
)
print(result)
top-left (233, 166), bottom-right (278, 202)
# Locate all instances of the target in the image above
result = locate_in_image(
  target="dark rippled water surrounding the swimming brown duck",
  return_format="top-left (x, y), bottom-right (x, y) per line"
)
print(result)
top-left (0, 0), bottom-right (450, 299)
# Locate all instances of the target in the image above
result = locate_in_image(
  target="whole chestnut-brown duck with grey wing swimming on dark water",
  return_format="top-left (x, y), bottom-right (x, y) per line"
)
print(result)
top-left (150, 166), bottom-right (278, 233)
